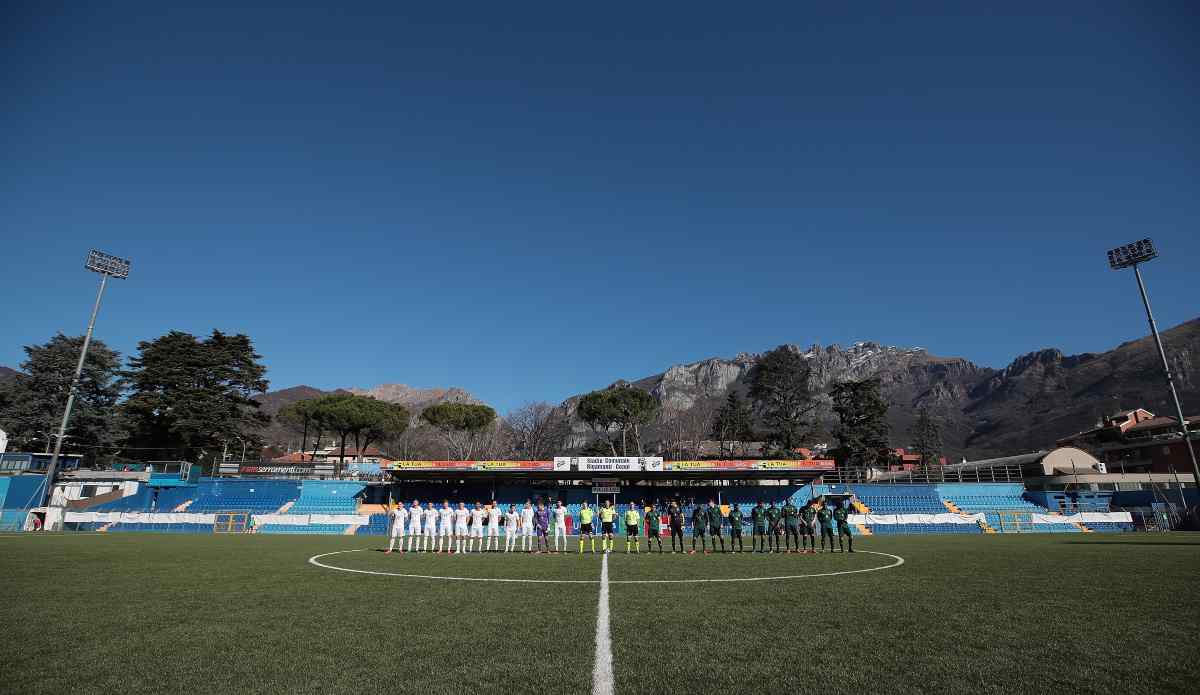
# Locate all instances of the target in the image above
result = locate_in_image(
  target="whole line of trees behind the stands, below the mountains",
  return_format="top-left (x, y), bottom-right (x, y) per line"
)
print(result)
top-left (0, 330), bottom-right (942, 466)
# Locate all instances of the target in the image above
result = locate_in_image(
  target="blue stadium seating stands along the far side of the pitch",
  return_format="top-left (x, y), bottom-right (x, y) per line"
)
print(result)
top-left (16, 474), bottom-right (1156, 535)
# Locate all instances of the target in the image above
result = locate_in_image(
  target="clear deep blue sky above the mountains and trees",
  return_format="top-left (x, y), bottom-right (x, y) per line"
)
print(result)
top-left (0, 2), bottom-right (1200, 409)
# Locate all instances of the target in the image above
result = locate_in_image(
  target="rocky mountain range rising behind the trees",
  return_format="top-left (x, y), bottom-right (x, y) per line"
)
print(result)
top-left (9, 318), bottom-right (1200, 460)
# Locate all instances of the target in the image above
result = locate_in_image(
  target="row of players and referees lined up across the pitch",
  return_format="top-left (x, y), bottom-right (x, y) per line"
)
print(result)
top-left (386, 498), bottom-right (854, 555)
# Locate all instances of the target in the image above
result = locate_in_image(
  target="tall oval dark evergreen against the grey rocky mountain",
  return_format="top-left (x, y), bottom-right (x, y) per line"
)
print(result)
top-left (750, 346), bottom-right (816, 459)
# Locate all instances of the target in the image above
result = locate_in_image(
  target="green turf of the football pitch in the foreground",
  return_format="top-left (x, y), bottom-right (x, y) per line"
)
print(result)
top-left (0, 533), bottom-right (1200, 695)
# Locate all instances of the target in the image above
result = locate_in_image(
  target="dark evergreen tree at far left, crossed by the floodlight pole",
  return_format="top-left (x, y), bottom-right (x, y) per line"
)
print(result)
top-left (0, 334), bottom-right (121, 461)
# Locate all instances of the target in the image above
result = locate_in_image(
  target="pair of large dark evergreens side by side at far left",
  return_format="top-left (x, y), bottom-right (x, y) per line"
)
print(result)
top-left (0, 330), bottom-right (269, 463)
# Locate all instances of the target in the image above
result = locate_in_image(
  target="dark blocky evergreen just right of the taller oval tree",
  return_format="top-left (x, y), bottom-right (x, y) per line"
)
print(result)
top-left (830, 377), bottom-right (889, 467)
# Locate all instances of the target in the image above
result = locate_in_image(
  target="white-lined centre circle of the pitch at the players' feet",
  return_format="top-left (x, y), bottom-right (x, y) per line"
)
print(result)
top-left (308, 547), bottom-right (905, 585)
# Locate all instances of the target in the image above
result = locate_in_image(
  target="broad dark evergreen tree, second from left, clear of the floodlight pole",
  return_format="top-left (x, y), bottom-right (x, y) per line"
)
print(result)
top-left (122, 330), bottom-right (270, 461)
